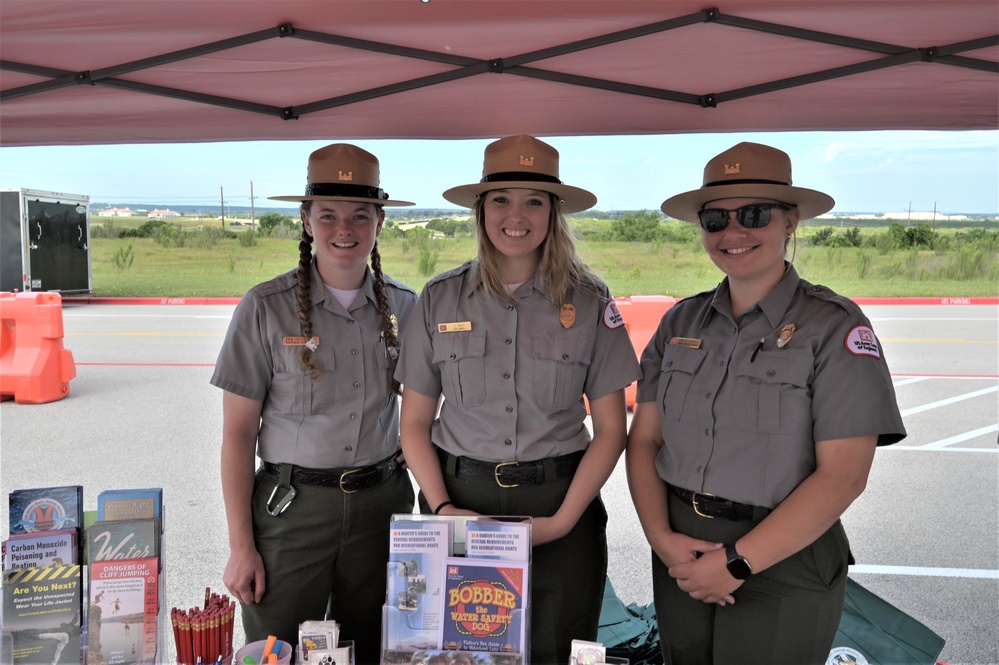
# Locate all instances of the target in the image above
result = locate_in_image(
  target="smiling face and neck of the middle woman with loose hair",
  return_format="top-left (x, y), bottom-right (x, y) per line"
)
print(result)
top-left (482, 189), bottom-right (552, 282)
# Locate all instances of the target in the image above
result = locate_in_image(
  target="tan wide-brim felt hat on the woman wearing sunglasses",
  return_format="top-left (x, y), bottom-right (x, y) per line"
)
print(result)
top-left (662, 143), bottom-right (836, 223)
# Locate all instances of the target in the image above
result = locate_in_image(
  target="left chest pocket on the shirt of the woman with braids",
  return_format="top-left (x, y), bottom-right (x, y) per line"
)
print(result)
top-left (267, 344), bottom-right (336, 416)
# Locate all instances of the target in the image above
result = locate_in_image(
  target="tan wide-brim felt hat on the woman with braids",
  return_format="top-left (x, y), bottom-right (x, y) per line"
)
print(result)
top-left (267, 143), bottom-right (416, 206)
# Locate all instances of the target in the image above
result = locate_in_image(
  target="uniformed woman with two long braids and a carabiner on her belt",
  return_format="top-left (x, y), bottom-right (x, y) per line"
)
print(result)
top-left (211, 144), bottom-right (416, 663)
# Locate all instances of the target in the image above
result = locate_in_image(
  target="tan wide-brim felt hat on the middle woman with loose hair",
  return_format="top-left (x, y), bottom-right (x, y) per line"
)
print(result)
top-left (443, 134), bottom-right (597, 214)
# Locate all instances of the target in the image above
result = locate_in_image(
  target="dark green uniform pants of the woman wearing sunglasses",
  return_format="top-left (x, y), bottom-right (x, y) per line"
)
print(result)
top-left (652, 492), bottom-right (851, 665)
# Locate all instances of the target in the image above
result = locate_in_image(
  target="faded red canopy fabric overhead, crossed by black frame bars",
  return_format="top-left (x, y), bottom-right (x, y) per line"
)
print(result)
top-left (0, 0), bottom-right (999, 146)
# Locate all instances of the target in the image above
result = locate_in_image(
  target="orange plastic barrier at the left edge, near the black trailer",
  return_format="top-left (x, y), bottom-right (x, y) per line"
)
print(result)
top-left (0, 292), bottom-right (76, 404)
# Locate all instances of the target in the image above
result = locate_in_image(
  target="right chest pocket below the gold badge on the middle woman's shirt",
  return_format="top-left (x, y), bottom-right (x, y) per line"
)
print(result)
top-left (532, 333), bottom-right (596, 411)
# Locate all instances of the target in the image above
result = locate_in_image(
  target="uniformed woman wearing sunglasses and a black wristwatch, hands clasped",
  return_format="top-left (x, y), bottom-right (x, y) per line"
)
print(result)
top-left (627, 143), bottom-right (905, 665)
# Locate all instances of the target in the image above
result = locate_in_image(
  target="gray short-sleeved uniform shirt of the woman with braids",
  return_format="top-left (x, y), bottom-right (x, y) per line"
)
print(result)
top-left (211, 260), bottom-right (416, 468)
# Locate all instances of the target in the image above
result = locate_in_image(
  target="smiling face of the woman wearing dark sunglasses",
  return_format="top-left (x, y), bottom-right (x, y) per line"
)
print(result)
top-left (701, 198), bottom-right (798, 286)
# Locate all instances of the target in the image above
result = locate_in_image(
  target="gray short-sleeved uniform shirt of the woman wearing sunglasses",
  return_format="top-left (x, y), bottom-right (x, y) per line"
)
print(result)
top-left (638, 268), bottom-right (905, 508)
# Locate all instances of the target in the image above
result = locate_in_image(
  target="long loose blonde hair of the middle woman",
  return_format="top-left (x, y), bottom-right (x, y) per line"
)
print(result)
top-left (475, 192), bottom-right (603, 307)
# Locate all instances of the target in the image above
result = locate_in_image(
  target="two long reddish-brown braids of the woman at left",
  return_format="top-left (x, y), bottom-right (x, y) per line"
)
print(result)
top-left (298, 201), bottom-right (399, 384)
